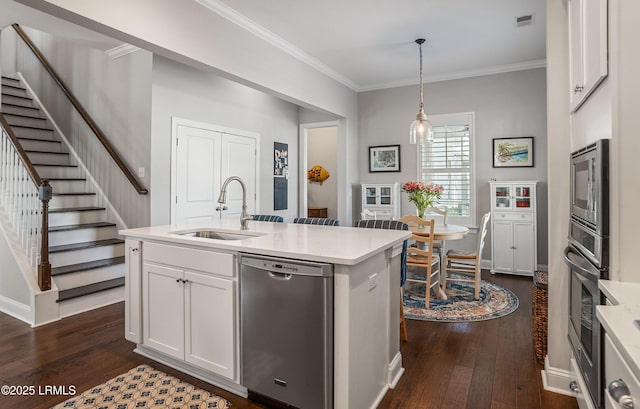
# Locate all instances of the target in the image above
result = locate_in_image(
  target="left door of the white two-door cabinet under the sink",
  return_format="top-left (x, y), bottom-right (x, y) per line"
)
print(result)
top-left (142, 263), bottom-right (184, 359)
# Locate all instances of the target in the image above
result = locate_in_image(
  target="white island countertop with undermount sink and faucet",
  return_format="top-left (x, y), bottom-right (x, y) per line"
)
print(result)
top-left (120, 219), bottom-right (411, 265)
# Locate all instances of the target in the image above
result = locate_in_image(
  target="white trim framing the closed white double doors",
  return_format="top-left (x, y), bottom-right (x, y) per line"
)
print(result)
top-left (170, 116), bottom-right (260, 223)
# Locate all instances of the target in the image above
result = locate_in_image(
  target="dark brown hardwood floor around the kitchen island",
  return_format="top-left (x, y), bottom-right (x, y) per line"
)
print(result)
top-left (0, 274), bottom-right (578, 409)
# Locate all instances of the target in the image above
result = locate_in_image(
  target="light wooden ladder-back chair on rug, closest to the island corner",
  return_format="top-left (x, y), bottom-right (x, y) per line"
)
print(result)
top-left (398, 215), bottom-right (442, 308)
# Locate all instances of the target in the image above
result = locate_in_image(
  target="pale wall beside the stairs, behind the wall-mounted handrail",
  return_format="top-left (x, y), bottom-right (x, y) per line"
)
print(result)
top-left (3, 26), bottom-right (151, 227)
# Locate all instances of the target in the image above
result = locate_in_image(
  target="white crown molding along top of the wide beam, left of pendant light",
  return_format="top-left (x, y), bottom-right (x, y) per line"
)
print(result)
top-left (196, 0), bottom-right (359, 91)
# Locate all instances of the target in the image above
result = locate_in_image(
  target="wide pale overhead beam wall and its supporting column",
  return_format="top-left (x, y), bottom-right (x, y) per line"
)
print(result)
top-left (19, 0), bottom-right (358, 223)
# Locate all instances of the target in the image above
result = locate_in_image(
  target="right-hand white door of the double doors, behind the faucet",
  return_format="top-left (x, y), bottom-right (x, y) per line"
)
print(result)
top-left (220, 133), bottom-right (257, 218)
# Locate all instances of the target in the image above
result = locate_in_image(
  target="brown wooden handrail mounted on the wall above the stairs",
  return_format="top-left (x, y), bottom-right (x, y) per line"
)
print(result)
top-left (11, 24), bottom-right (149, 195)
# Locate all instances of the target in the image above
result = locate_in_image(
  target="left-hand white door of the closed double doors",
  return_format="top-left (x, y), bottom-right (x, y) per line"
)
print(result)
top-left (173, 125), bottom-right (221, 223)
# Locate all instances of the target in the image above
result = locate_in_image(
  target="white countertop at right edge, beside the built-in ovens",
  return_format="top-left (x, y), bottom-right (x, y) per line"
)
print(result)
top-left (596, 280), bottom-right (640, 379)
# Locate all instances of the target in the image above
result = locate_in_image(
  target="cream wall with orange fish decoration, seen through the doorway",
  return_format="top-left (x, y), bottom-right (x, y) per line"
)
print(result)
top-left (306, 127), bottom-right (344, 223)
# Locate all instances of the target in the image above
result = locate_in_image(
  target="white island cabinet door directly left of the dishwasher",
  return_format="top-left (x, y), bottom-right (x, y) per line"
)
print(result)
top-left (184, 271), bottom-right (236, 379)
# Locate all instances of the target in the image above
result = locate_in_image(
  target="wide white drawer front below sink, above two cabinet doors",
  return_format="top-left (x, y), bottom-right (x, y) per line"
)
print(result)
top-left (142, 243), bottom-right (236, 277)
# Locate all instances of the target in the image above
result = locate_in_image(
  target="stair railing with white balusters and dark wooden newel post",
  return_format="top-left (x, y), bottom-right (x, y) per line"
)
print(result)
top-left (0, 112), bottom-right (52, 291)
